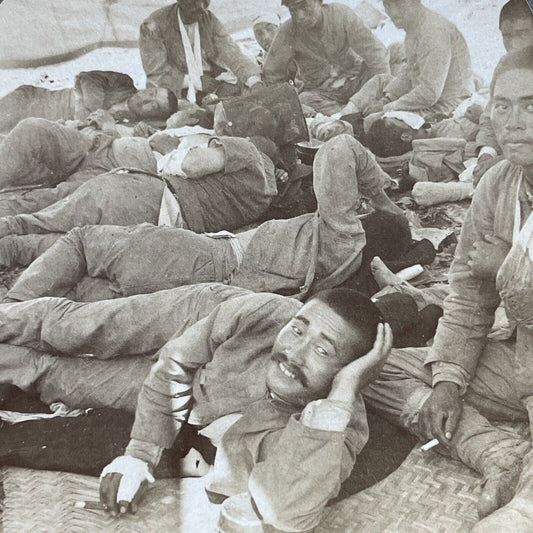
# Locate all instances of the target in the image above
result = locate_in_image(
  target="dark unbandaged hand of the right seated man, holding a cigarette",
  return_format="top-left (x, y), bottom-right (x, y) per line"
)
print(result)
top-left (418, 381), bottom-right (463, 447)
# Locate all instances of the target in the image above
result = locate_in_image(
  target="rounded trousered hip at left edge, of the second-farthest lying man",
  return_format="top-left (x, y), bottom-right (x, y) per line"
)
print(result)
top-left (0, 118), bottom-right (93, 189)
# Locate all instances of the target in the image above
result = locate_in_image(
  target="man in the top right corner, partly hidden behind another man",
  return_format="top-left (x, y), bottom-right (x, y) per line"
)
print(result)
top-left (474, 0), bottom-right (533, 181)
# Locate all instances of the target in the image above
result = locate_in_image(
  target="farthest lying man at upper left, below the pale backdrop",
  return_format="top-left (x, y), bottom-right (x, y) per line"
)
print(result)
top-left (0, 70), bottom-right (178, 133)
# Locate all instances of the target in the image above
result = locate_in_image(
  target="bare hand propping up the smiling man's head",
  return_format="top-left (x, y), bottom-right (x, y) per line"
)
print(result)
top-left (328, 324), bottom-right (392, 402)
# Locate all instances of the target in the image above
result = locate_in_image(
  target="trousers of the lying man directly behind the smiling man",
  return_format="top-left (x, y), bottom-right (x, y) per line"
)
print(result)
top-left (7, 224), bottom-right (237, 301)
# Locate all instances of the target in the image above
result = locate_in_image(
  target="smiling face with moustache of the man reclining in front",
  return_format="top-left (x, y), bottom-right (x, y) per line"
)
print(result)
top-left (267, 300), bottom-right (361, 406)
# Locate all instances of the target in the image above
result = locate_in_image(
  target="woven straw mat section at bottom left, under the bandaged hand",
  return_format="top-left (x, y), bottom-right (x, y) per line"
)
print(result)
top-left (0, 467), bottom-right (219, 533)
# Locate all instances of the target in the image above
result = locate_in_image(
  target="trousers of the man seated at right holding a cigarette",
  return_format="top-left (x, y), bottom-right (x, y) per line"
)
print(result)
top-left (365, 341), bottom-right (528, 474)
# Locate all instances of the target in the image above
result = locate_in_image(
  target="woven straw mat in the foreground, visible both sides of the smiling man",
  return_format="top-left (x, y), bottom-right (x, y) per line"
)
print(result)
top-left (0, 449), bottom-right (480, 533)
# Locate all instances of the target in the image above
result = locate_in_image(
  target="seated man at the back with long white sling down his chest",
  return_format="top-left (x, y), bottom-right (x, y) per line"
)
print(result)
top-left (139, 0), bottom-right (261, 103)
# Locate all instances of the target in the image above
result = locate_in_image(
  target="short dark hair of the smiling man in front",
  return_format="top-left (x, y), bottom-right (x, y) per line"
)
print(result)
top-left (308, 288), bottom-right (383, 360)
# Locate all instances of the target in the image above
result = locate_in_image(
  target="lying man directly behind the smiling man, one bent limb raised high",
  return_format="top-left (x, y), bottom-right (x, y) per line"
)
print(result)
top-left (3, 135), bottom-right (405, 300)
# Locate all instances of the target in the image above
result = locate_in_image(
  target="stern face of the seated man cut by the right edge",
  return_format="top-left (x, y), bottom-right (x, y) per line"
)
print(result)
top-left (491, 69), bottom-right (533, 172)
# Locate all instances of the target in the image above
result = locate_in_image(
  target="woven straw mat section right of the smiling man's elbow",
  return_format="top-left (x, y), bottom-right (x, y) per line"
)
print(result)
top-left (315, 448), bottom-right (480, 533)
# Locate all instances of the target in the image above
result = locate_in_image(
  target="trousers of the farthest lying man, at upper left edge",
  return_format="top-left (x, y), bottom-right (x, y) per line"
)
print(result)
top-left (0, 85), bottom-right (75, 133)
